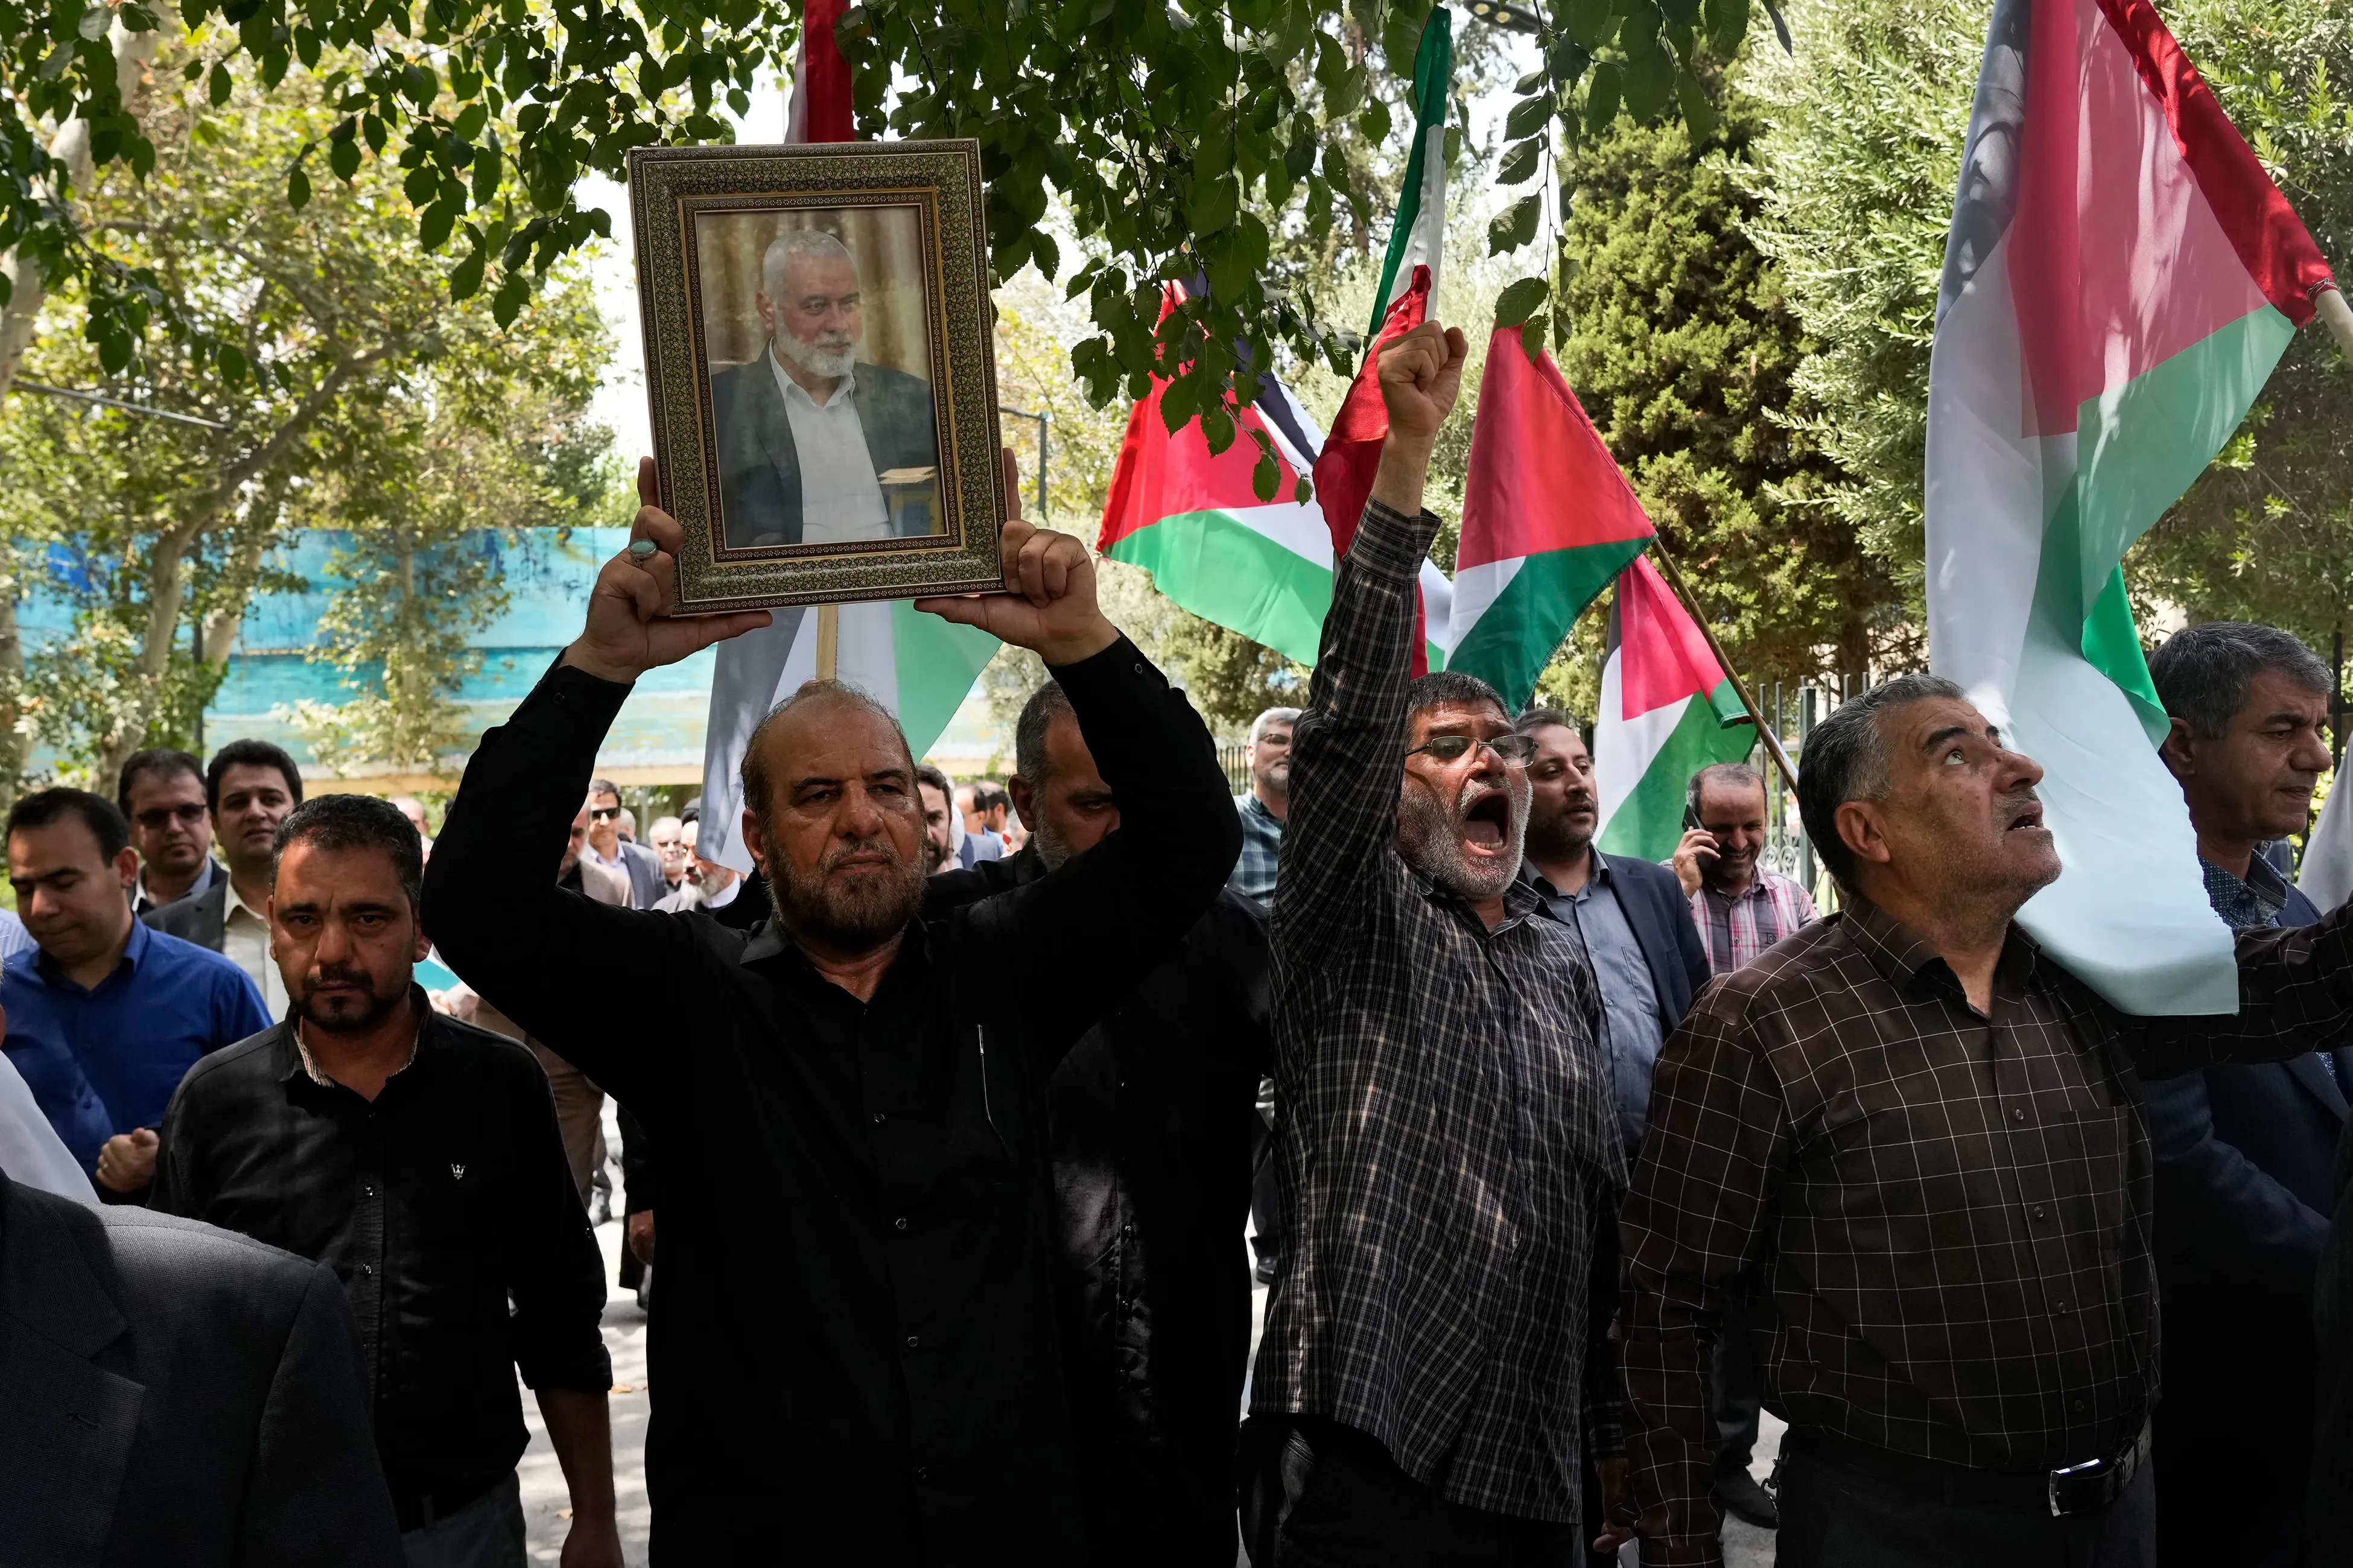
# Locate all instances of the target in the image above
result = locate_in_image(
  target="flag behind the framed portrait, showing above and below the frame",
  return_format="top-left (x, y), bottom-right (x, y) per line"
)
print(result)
top-left (696, 0), bottom-right (1002, 874)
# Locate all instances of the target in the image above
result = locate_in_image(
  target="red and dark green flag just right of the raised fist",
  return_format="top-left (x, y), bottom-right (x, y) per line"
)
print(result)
top-left (1447, 327), bottom-right (1657, 711)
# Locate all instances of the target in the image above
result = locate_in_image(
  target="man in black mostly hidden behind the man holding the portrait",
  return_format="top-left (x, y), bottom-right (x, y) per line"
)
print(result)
top-left (925, 681), bottom-right (1268, 1568)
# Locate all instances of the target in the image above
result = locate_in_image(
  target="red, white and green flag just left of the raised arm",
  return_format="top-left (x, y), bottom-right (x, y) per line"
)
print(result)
top-left (1096, 289), bottom-right (1449, 668)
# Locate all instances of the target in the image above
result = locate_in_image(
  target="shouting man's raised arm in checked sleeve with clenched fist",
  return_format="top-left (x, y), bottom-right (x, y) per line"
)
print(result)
top-left (1275, 323), bottom-right (1469, 956)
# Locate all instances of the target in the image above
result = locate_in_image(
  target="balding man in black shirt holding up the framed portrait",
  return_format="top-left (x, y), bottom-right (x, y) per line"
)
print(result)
top-left (426, 452), bottom-right (1240, 1566)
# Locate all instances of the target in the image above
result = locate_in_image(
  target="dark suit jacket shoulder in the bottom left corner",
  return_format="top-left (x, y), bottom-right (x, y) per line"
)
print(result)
top-left (0, 1175), bottom-right (402, 1568)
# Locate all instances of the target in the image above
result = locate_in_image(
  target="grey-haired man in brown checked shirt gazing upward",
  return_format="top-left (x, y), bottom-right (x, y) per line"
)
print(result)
top-left (1621, 676), bottom-right (2353, 1568)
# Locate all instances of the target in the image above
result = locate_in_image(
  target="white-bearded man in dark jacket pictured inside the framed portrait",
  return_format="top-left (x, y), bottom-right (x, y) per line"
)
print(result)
top-left (711, 229), bottom-right (946, 548)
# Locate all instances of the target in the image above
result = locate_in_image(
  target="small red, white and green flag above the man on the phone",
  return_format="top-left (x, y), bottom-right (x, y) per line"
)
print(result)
top-left (1590, 553), bottom-right (1758, 859)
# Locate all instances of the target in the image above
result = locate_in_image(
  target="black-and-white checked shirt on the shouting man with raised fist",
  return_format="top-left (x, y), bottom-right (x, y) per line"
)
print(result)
top-left (1252, 501), bottom-right (1624, 1521)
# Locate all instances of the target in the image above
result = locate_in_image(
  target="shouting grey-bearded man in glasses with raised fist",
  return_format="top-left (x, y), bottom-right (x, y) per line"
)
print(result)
top-left (1242, 323), bottom-right (1626, 1563)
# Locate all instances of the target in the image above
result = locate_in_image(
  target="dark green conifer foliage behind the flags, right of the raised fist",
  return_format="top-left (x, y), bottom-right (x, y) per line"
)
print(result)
top-left (1560, 72), bottom-right (1901, 683)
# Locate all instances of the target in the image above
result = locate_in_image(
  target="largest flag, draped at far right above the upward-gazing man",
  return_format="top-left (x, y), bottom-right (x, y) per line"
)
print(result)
top-left (1927, 0), bottom-right (2332, 1012)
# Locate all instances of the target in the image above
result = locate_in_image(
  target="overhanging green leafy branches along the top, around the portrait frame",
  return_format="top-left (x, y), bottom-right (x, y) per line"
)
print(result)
top-left (0, 0), bottom-right (1748, 478)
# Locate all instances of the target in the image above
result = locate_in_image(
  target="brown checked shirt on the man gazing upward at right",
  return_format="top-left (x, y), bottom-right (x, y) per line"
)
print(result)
top-left (1621, 900), bottom-right (2353, 1563)
